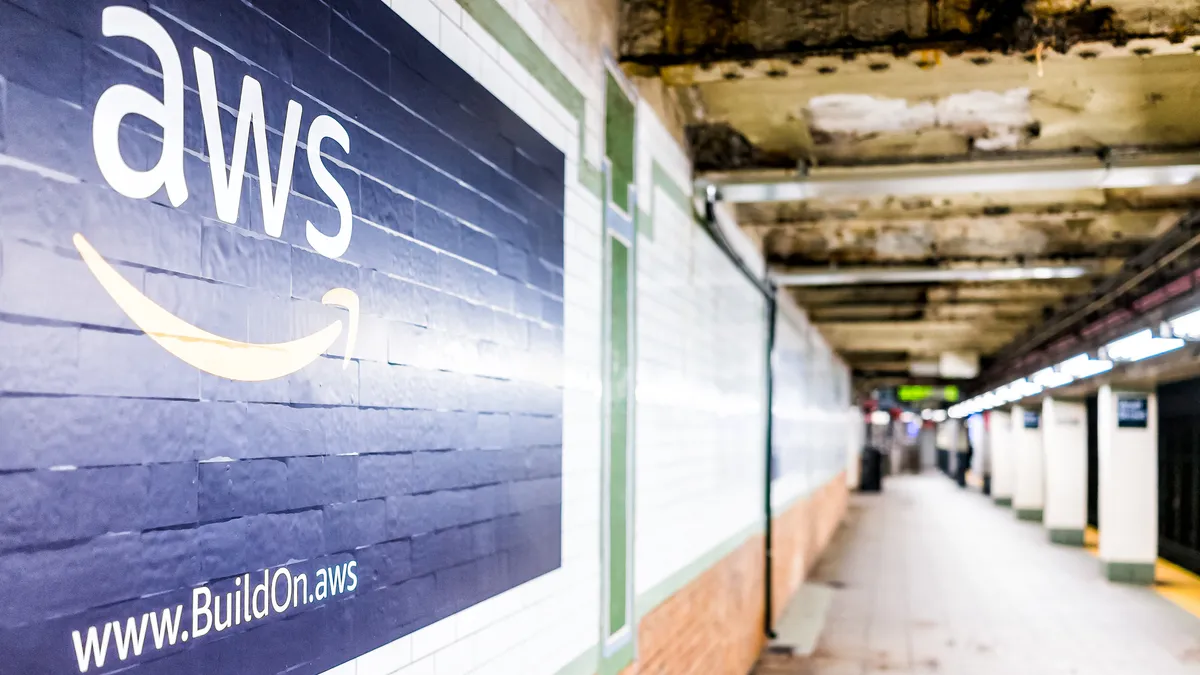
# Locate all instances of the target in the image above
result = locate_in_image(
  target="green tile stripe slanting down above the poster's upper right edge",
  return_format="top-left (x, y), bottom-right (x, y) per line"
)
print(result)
top-left (458, 0), bottom-right (602, 197)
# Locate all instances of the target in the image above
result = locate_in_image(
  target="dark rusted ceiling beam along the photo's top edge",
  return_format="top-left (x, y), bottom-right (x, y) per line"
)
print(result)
top-left (618, 0), bottom-right (1195, 70)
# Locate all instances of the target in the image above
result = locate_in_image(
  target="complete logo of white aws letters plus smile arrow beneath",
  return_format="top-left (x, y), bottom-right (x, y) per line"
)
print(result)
top-left (72, 7), bottom-right (359, 382)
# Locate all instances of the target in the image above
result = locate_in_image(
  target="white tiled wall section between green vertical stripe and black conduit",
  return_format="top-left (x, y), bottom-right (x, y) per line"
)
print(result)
top-left (635, 97), bottom-right (766, 593)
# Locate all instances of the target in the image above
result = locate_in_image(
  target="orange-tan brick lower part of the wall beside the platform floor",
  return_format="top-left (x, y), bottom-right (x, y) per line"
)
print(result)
top-left (623, 476), bottom-right (847, 675)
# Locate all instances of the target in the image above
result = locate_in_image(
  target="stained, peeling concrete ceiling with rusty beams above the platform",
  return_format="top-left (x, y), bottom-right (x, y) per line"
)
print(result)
top-left (618, 0), bottom-right (1200, 382)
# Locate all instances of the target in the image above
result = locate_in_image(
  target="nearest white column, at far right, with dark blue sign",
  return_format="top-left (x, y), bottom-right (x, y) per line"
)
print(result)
top-left (1097, 384), bottom-right (1158, 584)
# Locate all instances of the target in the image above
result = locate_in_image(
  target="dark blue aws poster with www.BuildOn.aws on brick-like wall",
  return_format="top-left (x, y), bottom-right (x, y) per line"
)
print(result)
top-left (0, 0), bottom-right (564, 675)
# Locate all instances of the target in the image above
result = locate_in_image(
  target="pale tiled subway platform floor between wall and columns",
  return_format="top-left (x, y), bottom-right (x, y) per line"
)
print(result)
top-left (755, 474), bottom-right (1200, 675)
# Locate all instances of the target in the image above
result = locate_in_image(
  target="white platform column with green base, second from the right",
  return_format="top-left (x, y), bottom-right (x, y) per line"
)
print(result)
top-left (1042, 399), bottom-right (1087, 546)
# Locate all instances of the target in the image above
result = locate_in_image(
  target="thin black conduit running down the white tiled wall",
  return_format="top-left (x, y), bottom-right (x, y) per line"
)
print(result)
top-left (696, 190), bottom-right (779, 639)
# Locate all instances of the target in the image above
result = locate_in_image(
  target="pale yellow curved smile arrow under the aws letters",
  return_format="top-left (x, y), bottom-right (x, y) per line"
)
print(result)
top-left (72, 234), bottom-right (359, 382)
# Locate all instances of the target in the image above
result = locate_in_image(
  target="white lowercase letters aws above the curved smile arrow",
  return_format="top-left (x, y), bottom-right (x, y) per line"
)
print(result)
top-left (91, 7), bottom-right (353, 258)
